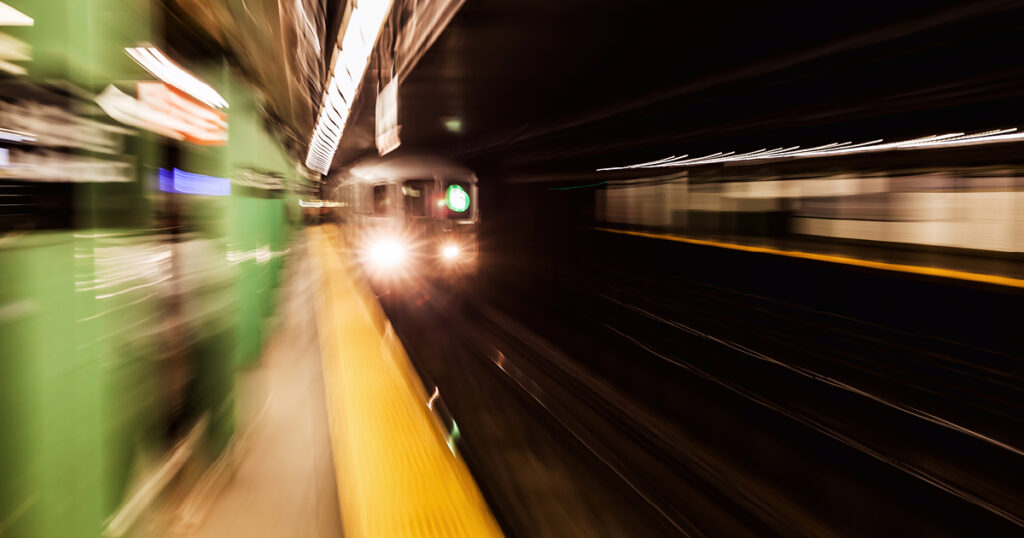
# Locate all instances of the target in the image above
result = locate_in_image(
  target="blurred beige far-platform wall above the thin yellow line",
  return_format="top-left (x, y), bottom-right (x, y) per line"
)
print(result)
top-left (595, 164), bottom-right (1024, 257)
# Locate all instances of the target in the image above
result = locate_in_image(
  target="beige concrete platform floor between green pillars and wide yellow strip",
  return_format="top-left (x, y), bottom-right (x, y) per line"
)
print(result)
top-left (153, 238), bottom-right (342, 538)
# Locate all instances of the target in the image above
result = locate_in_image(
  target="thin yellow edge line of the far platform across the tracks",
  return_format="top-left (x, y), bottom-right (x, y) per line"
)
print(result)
top-left (596, 227), bottom-right (1024, 288)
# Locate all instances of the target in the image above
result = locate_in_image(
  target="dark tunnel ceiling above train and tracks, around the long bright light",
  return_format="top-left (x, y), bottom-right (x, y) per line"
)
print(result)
top-left (175, 0), bottom-right (1024, 180)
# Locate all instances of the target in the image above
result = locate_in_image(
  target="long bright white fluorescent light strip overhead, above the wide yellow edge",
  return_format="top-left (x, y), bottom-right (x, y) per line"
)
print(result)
top-left (306, 0), bottom-right (391, 173)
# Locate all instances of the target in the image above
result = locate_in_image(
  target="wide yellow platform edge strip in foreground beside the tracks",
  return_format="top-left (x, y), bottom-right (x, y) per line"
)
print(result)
top-left (307, 224), bottom-right (502, 538)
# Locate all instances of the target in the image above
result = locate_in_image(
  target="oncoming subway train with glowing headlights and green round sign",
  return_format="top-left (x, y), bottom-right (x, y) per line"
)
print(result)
top-left (334, 156), bottom-right (480, 282)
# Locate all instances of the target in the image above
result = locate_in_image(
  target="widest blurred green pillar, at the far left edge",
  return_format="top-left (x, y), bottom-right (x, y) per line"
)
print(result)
top-left (0, 0), bottom-right (156, 537)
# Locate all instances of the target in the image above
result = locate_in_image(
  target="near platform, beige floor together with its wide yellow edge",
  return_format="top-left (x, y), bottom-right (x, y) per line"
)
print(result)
top-left (144, 225), bottom-right (502, 538)
